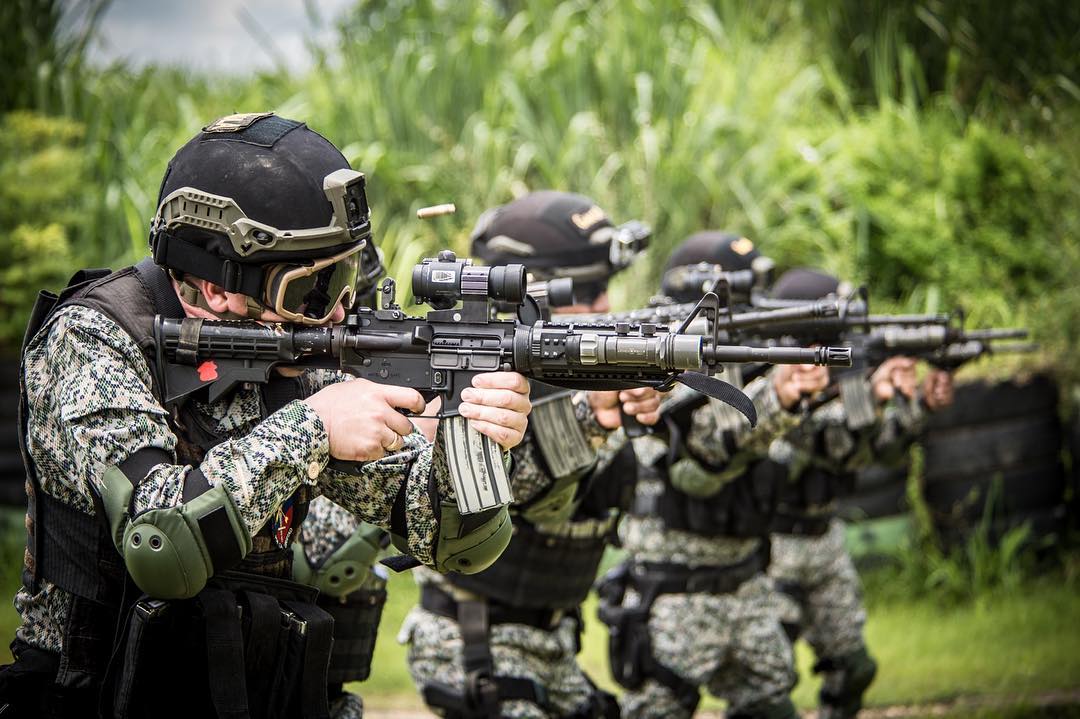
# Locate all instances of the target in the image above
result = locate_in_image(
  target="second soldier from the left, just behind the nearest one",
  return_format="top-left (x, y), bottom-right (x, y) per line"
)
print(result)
top-left (400, 192), bottom-right (659, 719)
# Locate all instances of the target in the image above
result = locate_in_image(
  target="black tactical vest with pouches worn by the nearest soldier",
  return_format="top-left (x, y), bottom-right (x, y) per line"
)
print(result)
top-left (9, 260), bottom-right (333, 717)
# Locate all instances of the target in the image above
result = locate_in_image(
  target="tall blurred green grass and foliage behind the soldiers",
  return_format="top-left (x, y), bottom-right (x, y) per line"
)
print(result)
top-left (0, 0), bottom-right (1080, 386)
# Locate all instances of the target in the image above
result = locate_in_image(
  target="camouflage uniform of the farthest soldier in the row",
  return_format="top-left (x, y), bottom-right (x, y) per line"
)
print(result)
top-left (769, 382), bottom-right (924, 708)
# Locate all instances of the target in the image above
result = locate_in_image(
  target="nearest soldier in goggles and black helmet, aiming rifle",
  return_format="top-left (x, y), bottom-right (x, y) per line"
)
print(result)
top-left (0, 112), bottom-right (529, 717)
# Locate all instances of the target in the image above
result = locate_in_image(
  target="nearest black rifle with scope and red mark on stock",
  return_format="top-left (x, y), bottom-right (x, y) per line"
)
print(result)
top-left (154, 252), bottom-right (851, 513)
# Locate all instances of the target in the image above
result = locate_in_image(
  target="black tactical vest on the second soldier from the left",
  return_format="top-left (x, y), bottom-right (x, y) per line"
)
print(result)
top-left (447, 443), bottom-right (637, 610)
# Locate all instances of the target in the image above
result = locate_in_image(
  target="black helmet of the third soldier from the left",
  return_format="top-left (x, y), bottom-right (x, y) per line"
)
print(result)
top-left (660, 230), bottom-right (772, 302)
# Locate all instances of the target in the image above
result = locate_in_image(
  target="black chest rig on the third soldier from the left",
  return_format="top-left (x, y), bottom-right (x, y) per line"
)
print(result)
top-left (632, 397), bottom-right (777, 538)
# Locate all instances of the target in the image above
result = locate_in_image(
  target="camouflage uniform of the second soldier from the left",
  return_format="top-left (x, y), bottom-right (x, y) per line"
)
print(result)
top-left (397, 393), bottom-right (625, 719)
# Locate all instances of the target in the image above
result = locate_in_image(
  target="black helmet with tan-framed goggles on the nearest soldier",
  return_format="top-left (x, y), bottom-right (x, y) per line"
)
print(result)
top-left (150, 112), bottom-right (377, 323)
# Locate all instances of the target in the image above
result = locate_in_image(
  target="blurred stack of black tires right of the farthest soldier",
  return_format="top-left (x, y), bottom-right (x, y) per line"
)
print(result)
top-left (922, 376), bottom-right (1065, 546)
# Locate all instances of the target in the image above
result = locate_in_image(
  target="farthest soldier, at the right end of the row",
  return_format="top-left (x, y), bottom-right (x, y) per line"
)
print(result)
top-left (756, 269), bottom-right (953, 719)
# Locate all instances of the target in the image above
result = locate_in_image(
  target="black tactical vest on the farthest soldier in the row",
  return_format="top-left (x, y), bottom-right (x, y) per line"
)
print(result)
top-left (754, 460), bottom-right (855, 537)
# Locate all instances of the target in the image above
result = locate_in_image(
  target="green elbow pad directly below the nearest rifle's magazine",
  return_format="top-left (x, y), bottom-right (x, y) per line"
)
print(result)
top-left (435, 502), bottom-right (513, 574)
